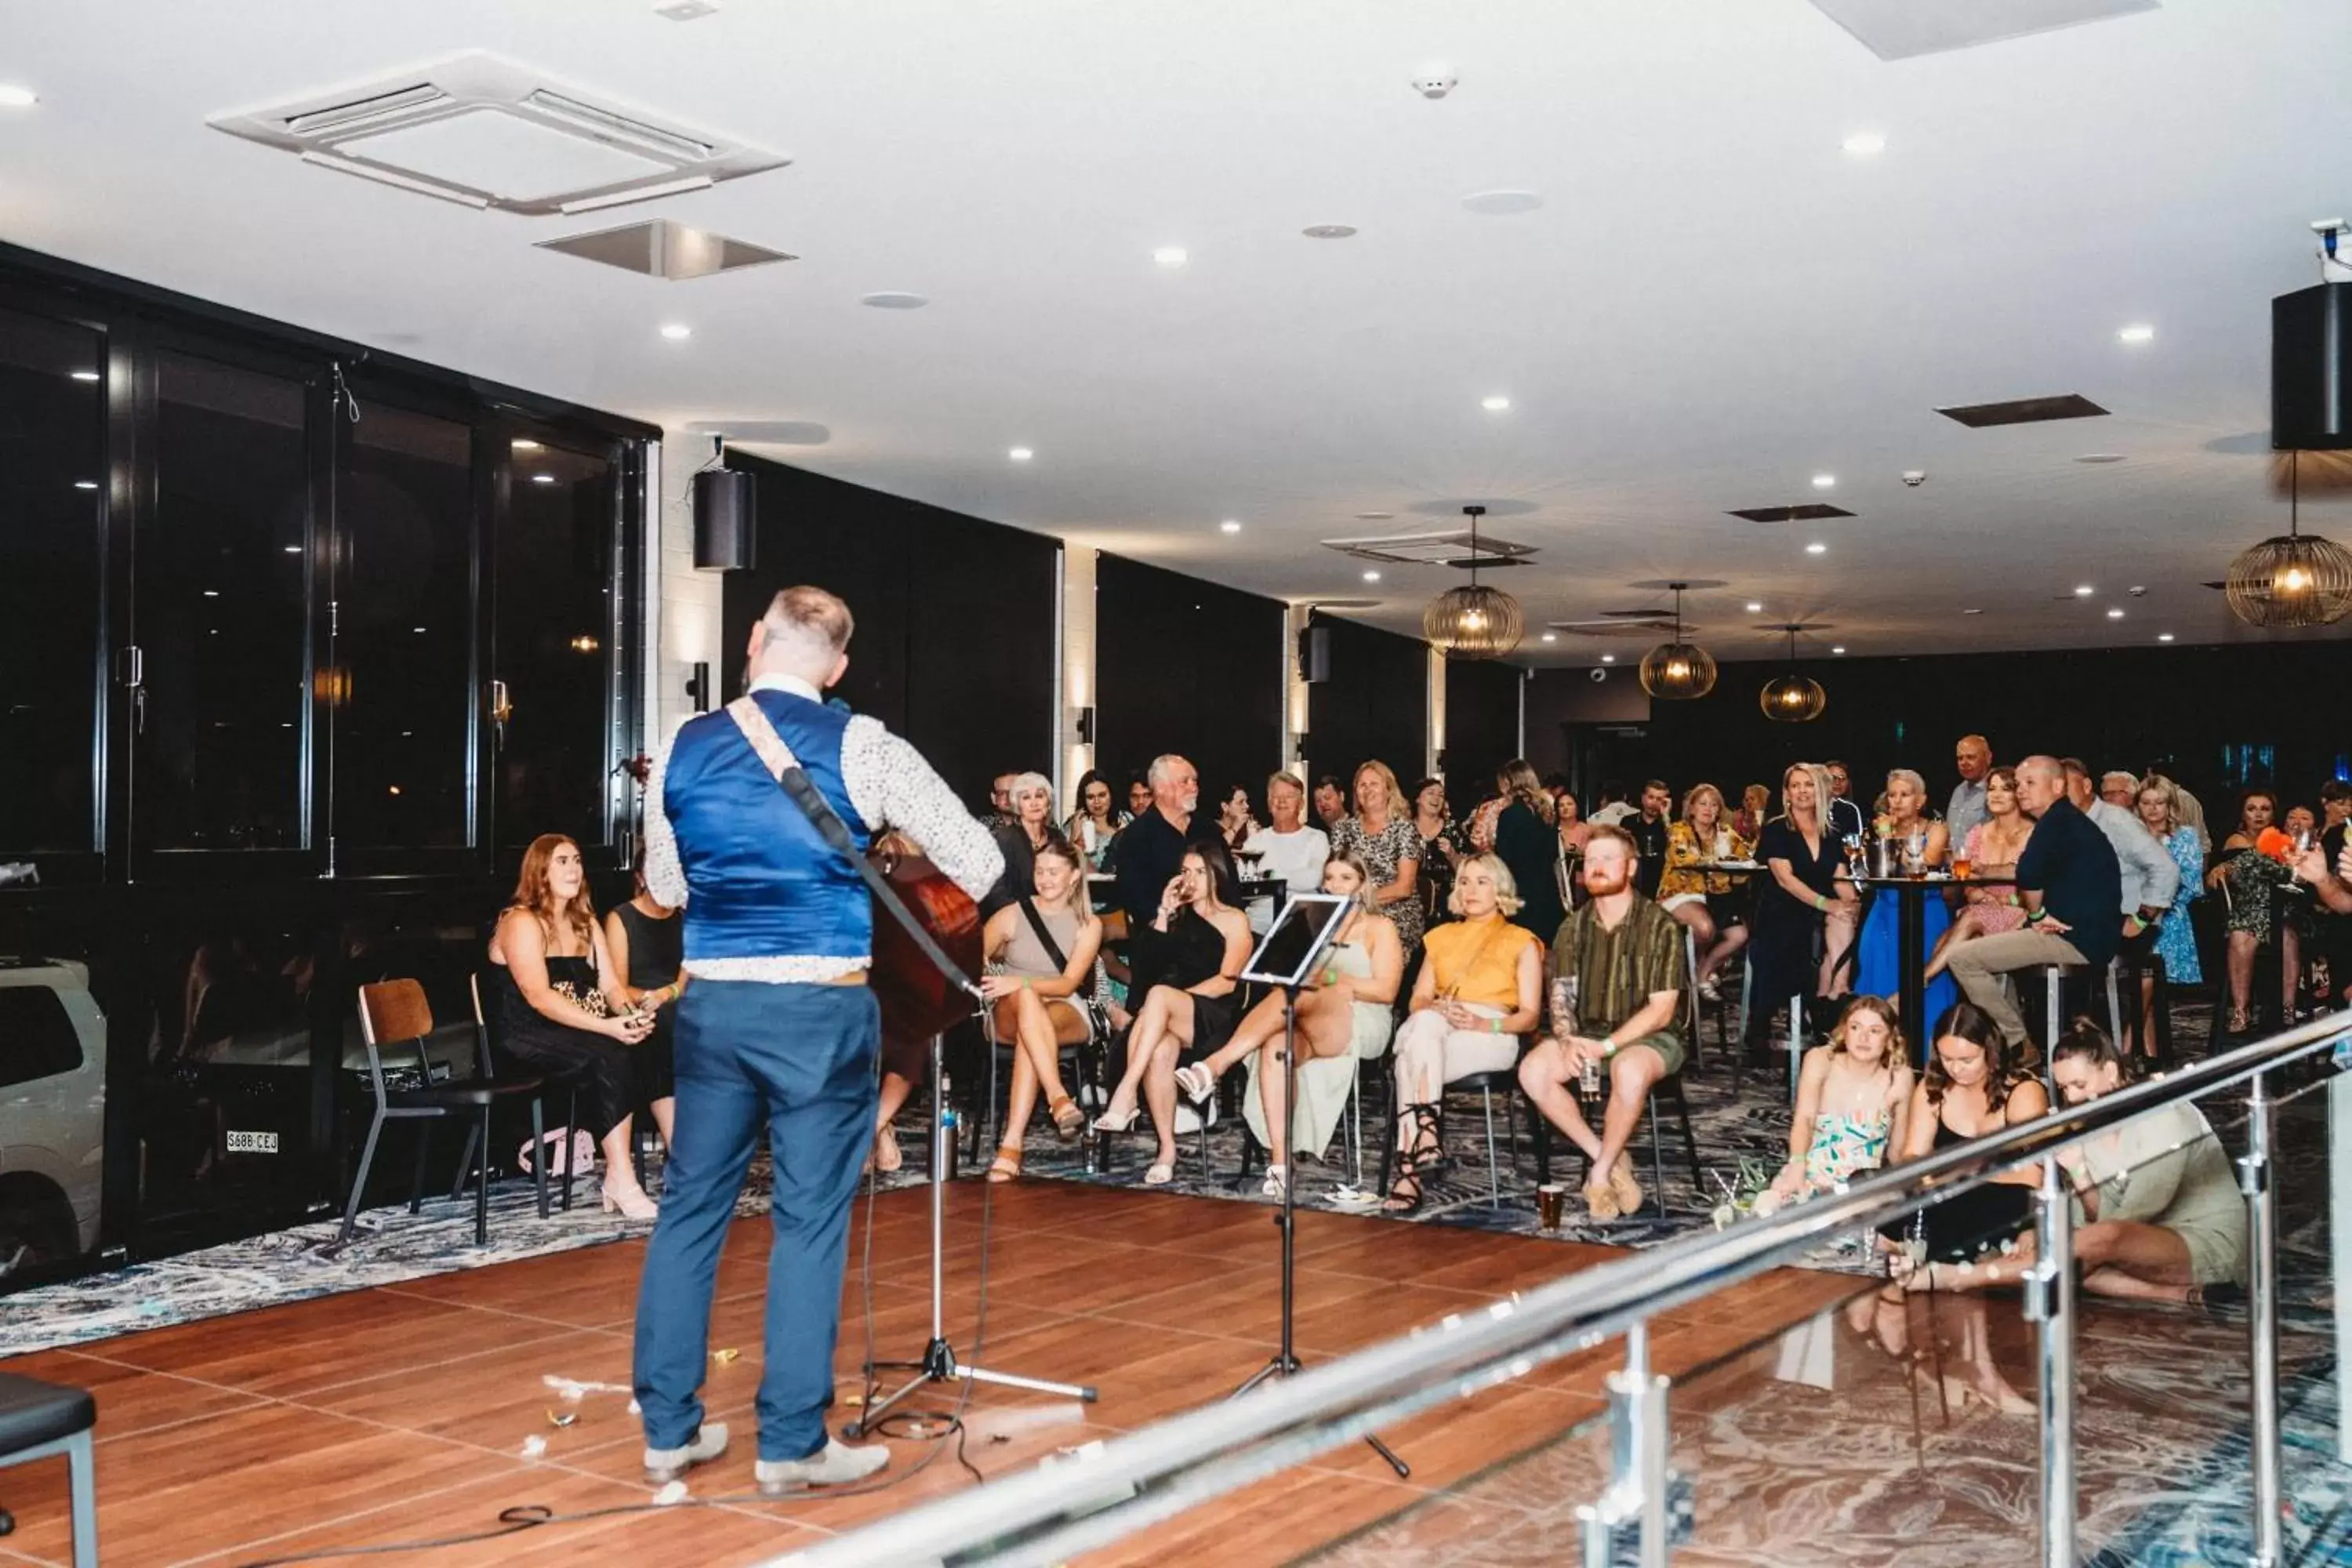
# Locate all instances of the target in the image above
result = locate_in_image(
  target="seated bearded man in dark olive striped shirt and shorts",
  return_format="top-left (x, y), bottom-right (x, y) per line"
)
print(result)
top-left (1519, 827), bottom-right (1691, 1220)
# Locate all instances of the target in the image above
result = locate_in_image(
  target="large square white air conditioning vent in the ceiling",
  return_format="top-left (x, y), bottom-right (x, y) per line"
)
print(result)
top-left (209, 52), bottom-right (788, 216)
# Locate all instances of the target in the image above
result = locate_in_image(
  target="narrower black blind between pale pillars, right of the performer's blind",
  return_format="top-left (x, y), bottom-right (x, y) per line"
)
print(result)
top-left (1094, 553), bottom-right (1287, 820)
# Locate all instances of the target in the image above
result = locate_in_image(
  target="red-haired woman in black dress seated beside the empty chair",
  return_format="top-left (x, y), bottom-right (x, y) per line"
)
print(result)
top-left (489, 832), bottom-right (661, 1220)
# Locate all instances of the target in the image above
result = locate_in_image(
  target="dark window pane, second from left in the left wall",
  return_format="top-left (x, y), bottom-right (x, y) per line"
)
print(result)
top-left (134, 353), bottom-right (310, 848)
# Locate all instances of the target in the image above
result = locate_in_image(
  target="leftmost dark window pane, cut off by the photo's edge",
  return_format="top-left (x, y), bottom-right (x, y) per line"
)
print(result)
top-left (0, 310), bottom-right (106, 860)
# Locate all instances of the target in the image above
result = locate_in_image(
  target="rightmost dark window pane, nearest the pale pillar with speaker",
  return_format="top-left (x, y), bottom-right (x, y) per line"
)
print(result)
top-left (492, 442), bottom-right (616, 848)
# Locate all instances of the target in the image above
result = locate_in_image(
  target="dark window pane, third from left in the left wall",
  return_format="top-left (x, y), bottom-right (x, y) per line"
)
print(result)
top-left (336, 402), bottom-right (473, 848)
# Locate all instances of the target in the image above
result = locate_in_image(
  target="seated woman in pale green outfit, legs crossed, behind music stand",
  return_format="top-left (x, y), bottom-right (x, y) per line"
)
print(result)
top-left (1176, 855), bottom-right (1404, 1196)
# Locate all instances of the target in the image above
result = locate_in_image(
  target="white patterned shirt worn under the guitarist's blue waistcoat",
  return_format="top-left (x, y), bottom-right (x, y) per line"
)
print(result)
top-left (644, 675), bottom-right (1004, 985)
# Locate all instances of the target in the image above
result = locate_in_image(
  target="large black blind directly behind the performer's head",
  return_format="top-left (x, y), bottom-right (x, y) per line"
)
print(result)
top-left (722, 452), bottom-right (1061, 806)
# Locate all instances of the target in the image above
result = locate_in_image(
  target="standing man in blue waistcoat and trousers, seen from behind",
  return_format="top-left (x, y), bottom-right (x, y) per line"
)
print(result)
top-left (635, 588), bottom-right (1004, 1493)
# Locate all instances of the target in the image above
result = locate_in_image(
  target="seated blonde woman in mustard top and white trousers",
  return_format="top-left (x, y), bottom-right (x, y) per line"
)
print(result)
top-left (1388, 855), bottom-right (1543, 1213)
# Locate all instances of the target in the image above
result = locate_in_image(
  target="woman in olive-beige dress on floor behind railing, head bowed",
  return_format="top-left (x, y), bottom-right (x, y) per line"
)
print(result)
top-left (1891, 1018), bottom-right (2246, 1307)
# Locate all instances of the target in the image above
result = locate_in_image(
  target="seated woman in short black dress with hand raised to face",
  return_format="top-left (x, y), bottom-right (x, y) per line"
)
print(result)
top-left (1094, 841), bottom-right (1251, 1187)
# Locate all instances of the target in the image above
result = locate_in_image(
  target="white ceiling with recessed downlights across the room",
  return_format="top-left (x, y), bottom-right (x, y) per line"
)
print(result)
top-left (0, 0), bottom-right (2352, 663)
